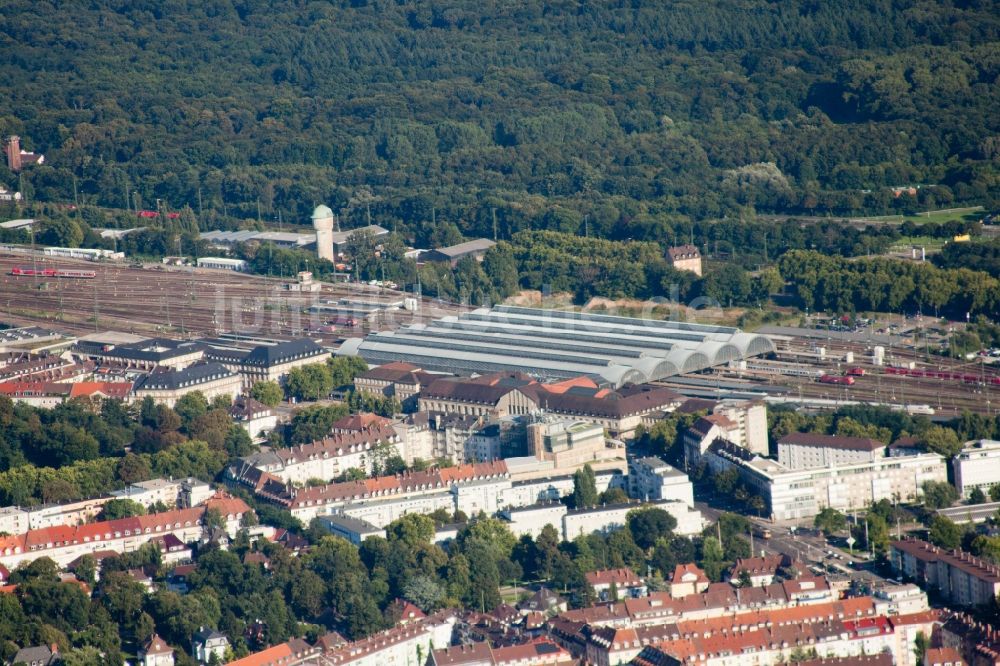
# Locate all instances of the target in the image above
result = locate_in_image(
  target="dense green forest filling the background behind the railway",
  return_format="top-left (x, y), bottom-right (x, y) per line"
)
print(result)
top-left (0, 0), bottom-right (1000, 239)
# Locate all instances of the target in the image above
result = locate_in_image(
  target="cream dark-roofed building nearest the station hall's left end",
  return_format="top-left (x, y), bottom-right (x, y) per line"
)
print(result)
top-left (205, 338), bottom-right (330, 389)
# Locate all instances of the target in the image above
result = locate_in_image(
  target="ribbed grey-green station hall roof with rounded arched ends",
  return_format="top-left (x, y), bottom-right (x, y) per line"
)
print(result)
top-left (337, 305), bottom-right (774, 388)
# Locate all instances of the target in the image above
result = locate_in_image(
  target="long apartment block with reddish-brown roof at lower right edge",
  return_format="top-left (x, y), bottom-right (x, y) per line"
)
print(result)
top-left (889, 539), bottom-right (1000, 606)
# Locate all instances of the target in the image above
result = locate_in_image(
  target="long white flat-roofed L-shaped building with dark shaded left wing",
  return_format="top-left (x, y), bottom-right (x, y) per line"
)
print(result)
top-left (705, 440), bottom-right (948, 520)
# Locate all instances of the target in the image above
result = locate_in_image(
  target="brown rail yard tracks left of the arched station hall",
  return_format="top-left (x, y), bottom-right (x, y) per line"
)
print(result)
top-left (0, 253), bottom-right (457, 341)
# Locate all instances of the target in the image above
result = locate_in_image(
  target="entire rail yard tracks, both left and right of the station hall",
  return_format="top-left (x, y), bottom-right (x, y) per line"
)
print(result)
top-left (0, 249), bottom-right (1000, 418)
